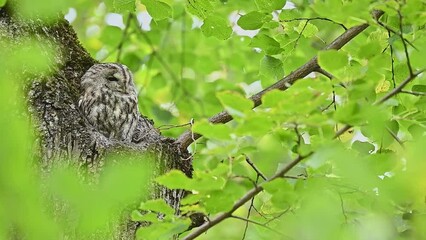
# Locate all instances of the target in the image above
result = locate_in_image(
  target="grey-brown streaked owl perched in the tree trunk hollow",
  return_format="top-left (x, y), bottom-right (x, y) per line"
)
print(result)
top-left (78, 63), bottom-right (140, 142)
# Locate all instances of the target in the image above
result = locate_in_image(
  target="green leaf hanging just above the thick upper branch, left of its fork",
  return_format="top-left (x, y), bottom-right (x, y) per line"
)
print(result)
top-left (259, 55), bottom-right (284, 86)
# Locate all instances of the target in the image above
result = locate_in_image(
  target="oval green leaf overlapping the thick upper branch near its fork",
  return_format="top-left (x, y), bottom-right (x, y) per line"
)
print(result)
top-left (318, 50), bottom-right (348, 72)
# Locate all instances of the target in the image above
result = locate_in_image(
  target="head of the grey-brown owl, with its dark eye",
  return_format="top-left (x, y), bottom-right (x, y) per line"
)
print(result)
top-left (81, 63), bottom-right (135, 94)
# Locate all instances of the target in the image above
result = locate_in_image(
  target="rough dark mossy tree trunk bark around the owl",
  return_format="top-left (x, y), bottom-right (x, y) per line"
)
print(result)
top-left (0, 5), bottom-right (192, 239)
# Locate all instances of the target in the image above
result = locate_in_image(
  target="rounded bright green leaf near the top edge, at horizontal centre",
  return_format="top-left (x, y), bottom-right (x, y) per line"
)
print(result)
top-left (201, 16), bottom-right (232, 40)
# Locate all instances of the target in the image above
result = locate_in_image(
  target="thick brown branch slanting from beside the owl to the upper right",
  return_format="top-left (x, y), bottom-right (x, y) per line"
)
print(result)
top-left (176, 11), bottom-right (383, 149)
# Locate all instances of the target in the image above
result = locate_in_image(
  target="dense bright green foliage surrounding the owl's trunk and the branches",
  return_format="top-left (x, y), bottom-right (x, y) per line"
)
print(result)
top-left (0, 0), bottom-right (426, 239)
